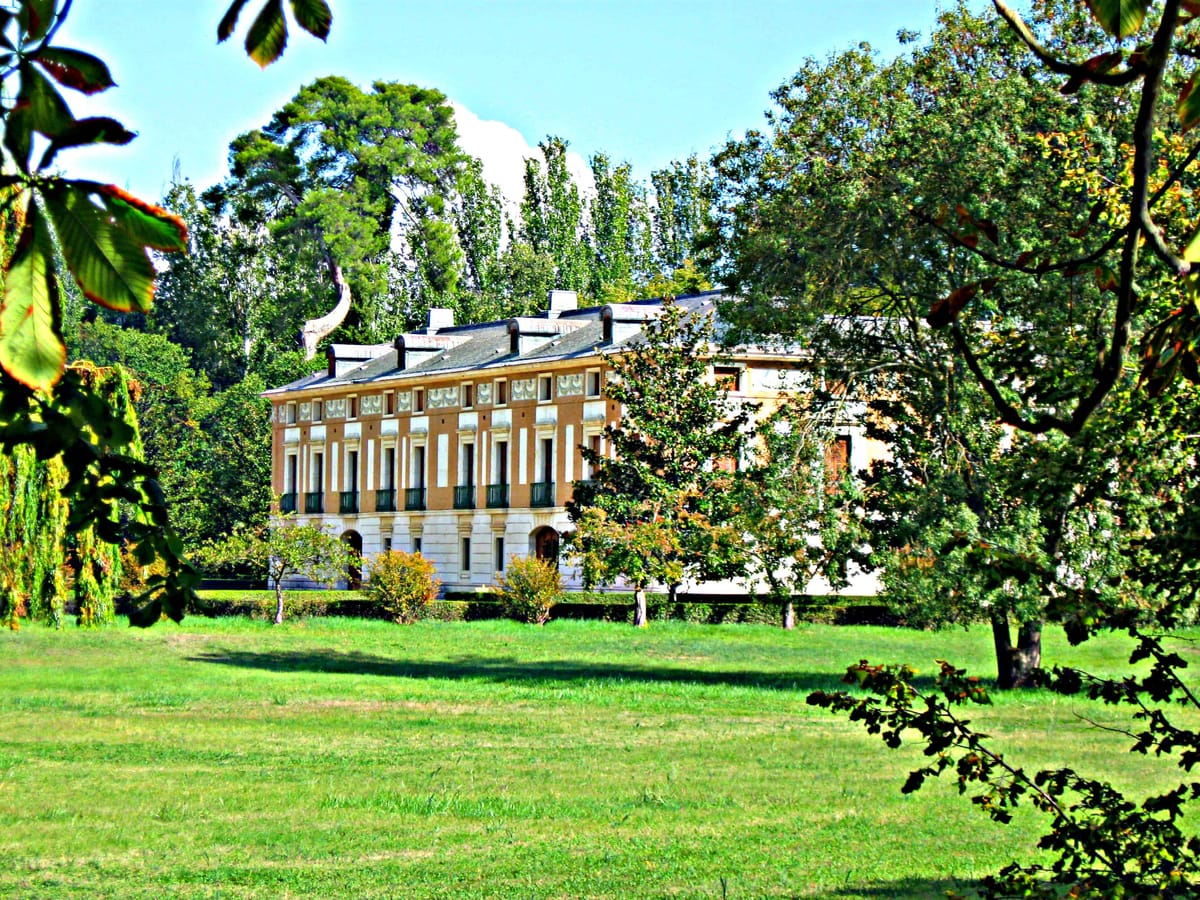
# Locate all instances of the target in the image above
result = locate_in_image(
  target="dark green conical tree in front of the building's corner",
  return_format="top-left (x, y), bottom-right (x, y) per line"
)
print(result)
top-left (566, 302), bottom-right (751, 625)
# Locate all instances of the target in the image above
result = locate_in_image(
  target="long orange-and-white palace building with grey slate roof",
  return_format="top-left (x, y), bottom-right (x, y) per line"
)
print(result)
top-left (266, 290), bottom-right (877, 594)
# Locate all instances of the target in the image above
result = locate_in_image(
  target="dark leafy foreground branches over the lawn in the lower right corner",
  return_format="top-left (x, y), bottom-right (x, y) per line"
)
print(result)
top-left (808, 652), bottom-right (1200, 898)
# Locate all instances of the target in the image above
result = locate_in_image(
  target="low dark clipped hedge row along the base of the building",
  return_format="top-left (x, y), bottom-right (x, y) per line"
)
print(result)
top-left (192, 590), bottom-right (900, 625)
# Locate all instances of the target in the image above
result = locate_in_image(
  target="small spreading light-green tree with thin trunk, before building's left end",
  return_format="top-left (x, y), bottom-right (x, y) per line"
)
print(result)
top-left (197, 516), bottom-right (359, 625)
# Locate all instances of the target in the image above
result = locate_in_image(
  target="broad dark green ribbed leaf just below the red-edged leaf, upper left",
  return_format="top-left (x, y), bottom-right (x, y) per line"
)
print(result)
top-left (43, 182), bottom-right (154, 312)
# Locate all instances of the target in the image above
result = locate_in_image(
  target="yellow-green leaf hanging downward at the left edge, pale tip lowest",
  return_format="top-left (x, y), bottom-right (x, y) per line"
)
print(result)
top-left (0, 204), bottom-right (67, 391)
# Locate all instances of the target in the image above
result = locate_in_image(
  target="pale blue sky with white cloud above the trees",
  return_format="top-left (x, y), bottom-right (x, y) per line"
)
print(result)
top-left (56, 0), bottom-right (969, 200)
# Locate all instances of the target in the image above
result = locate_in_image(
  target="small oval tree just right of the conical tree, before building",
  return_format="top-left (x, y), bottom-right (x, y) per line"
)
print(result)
top-left (736, 403), bottom-right (868, 629)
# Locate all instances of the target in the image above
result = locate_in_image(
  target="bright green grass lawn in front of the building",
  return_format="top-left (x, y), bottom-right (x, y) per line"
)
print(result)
top-left (0, 619), bottom-right (1195, 899)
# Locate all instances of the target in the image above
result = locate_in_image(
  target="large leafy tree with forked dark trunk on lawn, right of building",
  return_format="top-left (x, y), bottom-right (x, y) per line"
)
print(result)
top-left (716, 6), bottom-right (1142, 685)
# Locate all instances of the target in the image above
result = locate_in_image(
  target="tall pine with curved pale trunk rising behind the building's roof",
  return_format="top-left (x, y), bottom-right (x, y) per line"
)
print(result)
top-left (223, 76), bottom-right (466, 355)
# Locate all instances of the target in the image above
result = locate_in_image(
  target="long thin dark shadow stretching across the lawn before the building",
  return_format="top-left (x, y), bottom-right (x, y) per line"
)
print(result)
top-left (188, 649), bottom-right (883, 692)
